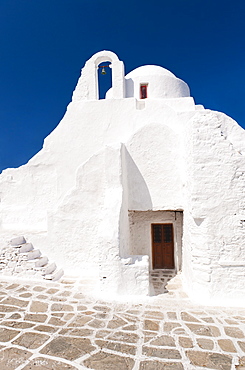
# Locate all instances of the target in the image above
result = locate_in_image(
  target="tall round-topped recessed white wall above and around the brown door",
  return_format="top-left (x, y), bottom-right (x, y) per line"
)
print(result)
top-left (119, 123), bottom-right (183, 269)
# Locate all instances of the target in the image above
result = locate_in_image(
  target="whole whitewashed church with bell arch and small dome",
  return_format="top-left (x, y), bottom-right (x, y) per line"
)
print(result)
top-left (0, 51), bottom-right (245, 305)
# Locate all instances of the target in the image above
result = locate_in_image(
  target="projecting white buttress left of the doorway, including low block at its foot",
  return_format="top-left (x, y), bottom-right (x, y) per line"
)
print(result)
top-left (45, 145), bottom-right (149, 295)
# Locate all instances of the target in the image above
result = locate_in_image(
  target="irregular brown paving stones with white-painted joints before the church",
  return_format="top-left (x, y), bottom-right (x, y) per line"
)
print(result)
top-left (0, 271), bottom-right (245, 370)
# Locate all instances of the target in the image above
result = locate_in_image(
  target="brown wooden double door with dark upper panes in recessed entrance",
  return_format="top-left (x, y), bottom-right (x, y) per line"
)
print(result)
top-left (151, 224), bottom-right (174, 269)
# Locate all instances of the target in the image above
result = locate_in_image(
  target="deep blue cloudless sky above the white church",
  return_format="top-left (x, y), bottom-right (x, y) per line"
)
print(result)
top-left (0, 0), bottom-right (245, 171)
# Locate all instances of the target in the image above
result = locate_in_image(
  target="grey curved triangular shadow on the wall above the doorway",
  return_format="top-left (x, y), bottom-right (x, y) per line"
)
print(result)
top-left (124, 147), bottom-right (152, 211)
